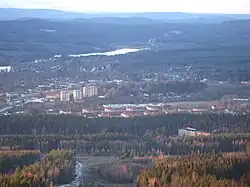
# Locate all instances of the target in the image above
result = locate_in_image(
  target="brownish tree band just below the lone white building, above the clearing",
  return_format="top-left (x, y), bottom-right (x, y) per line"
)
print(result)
top-left (0, 131), bottom-right (250, 157)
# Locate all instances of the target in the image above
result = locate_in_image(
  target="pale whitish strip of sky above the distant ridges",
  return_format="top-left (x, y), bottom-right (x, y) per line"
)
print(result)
top-left (0, 0), bottom-right (250, 14)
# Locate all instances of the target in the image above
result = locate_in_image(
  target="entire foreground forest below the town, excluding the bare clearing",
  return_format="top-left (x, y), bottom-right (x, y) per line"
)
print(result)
top-left (0, 114), bottom-right (250, 187)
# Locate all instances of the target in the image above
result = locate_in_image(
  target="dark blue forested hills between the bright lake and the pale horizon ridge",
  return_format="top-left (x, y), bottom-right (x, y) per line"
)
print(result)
top-left (0, 18), bottom-right (250, 63)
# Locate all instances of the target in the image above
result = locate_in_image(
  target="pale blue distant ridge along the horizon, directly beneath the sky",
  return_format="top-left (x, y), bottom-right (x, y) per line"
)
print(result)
top-left (0, 8), bottom-right (250, 22)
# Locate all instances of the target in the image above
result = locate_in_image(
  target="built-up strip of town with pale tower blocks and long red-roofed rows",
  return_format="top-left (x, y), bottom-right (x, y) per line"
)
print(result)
top-left (0, 63), bottom-right (250, 117)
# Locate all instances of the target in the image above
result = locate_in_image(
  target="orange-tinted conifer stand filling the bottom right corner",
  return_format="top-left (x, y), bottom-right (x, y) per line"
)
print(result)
top-left (137, 153), bottom-right (250, 187)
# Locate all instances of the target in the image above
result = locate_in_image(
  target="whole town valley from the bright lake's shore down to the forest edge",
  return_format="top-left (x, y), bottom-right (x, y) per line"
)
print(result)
top-left (0, 49), bottom-right (250, 117)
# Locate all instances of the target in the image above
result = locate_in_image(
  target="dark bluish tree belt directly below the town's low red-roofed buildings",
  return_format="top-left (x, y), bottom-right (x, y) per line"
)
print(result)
top-left (0, 114), bottom-right (250, 136)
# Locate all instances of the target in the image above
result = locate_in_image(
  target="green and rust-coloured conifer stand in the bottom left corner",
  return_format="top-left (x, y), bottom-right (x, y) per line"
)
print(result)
top-left (0, 150), bottom-right (75, 187)
